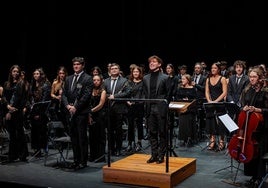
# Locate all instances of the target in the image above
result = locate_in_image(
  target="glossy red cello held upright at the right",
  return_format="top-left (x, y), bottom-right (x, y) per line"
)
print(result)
top-left (228, 111), bottom-right (263, 163)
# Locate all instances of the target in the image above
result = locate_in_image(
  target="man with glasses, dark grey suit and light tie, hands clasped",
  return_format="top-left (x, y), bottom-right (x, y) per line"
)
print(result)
top-left (104, 63), bottom-right (131, 156)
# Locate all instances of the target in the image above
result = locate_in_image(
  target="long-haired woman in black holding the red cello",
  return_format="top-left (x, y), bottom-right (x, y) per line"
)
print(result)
top-left (240, 66), bottom-right (268, 187)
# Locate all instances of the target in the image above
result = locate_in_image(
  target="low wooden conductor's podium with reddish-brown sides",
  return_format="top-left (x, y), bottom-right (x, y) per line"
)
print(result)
top-left (102, 154), bottom-right (196, 188)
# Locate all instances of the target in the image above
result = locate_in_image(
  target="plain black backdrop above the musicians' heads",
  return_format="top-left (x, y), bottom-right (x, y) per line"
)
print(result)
top-left (0, 0), bottom-right (266, 84)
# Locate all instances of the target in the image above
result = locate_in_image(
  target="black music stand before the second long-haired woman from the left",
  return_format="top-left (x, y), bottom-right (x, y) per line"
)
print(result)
top-left (28, 101), bottom-right (51, 162)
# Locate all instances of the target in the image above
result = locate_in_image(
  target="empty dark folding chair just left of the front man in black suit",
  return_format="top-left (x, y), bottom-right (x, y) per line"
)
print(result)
top-left (44, 121), bottom-right (71, 166)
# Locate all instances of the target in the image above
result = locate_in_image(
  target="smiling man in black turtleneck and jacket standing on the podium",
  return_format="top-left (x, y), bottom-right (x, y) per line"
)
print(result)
top-left (143, 55), bottom-right (169, 164)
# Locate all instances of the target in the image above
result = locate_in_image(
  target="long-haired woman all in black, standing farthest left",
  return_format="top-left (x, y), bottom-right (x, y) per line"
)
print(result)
top-left (3, 65), bottom-right (29, 162)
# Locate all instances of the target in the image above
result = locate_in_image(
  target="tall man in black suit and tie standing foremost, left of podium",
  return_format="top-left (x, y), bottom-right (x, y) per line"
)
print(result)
top-left (62, 57), bottom-right (93, 169)
